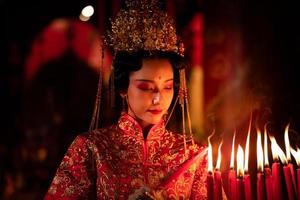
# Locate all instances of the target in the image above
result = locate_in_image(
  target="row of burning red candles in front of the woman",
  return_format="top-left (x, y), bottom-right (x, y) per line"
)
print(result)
top-left (207, 121), bottom-right (300, 200)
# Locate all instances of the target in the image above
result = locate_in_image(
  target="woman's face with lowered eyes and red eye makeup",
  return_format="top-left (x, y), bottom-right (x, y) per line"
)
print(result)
top-left (127, 59), bottom-right (174, 128)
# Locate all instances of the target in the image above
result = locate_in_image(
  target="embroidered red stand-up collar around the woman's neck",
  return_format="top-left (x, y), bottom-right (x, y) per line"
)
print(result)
top-left (118, 113), bottom-right (165, 140)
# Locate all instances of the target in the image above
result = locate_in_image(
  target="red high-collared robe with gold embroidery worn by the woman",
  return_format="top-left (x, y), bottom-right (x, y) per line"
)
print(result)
top-left (45, 114), bottom-right (207, 200)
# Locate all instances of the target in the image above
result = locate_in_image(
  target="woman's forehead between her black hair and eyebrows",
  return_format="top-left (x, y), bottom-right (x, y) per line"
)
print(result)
top-left (131, 59), bottom-right (173, 80)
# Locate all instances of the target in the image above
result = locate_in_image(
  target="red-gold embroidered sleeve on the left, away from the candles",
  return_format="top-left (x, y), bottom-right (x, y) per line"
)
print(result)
top-left (44, 135), bottom-right (95, 200)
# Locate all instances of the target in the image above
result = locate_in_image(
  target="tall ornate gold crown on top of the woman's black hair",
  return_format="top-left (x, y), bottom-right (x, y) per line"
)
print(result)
top-left (106, 0), bottom-right (184, 56)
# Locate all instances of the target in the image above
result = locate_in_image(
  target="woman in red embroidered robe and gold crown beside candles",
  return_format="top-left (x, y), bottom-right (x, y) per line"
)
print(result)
top-left (45, 1), bottom-right (206, 199)
